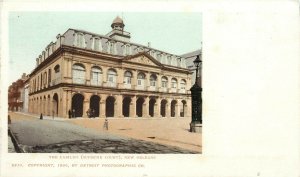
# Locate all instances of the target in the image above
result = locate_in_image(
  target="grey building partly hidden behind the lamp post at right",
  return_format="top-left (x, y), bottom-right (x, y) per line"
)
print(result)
top-left (181, 49), bottom-right (202, 85)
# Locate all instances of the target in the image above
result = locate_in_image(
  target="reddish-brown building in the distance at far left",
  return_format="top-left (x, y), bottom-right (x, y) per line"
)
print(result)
top-left (8, 73), bottom-right (27, 111)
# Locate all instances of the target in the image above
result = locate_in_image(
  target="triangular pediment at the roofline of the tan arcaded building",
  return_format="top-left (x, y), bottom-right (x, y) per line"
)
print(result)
top-left (125, 53), bottom-right (161, 66)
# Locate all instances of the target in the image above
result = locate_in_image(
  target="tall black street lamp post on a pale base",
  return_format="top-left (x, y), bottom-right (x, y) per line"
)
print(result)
top-left (190, 55), bottom-right (202, 133)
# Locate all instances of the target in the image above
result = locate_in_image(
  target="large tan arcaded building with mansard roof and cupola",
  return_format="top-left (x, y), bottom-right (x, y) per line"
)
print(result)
top-left (28, 17), bottom-right (192, 118)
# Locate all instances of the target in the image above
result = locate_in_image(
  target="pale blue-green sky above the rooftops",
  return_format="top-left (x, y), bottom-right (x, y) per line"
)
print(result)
top-left (8, 12), bottom-right (202, 83)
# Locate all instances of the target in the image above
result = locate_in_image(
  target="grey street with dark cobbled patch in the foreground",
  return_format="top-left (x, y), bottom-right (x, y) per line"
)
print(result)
top-left (10, 113), bottom-right (199, 153)
